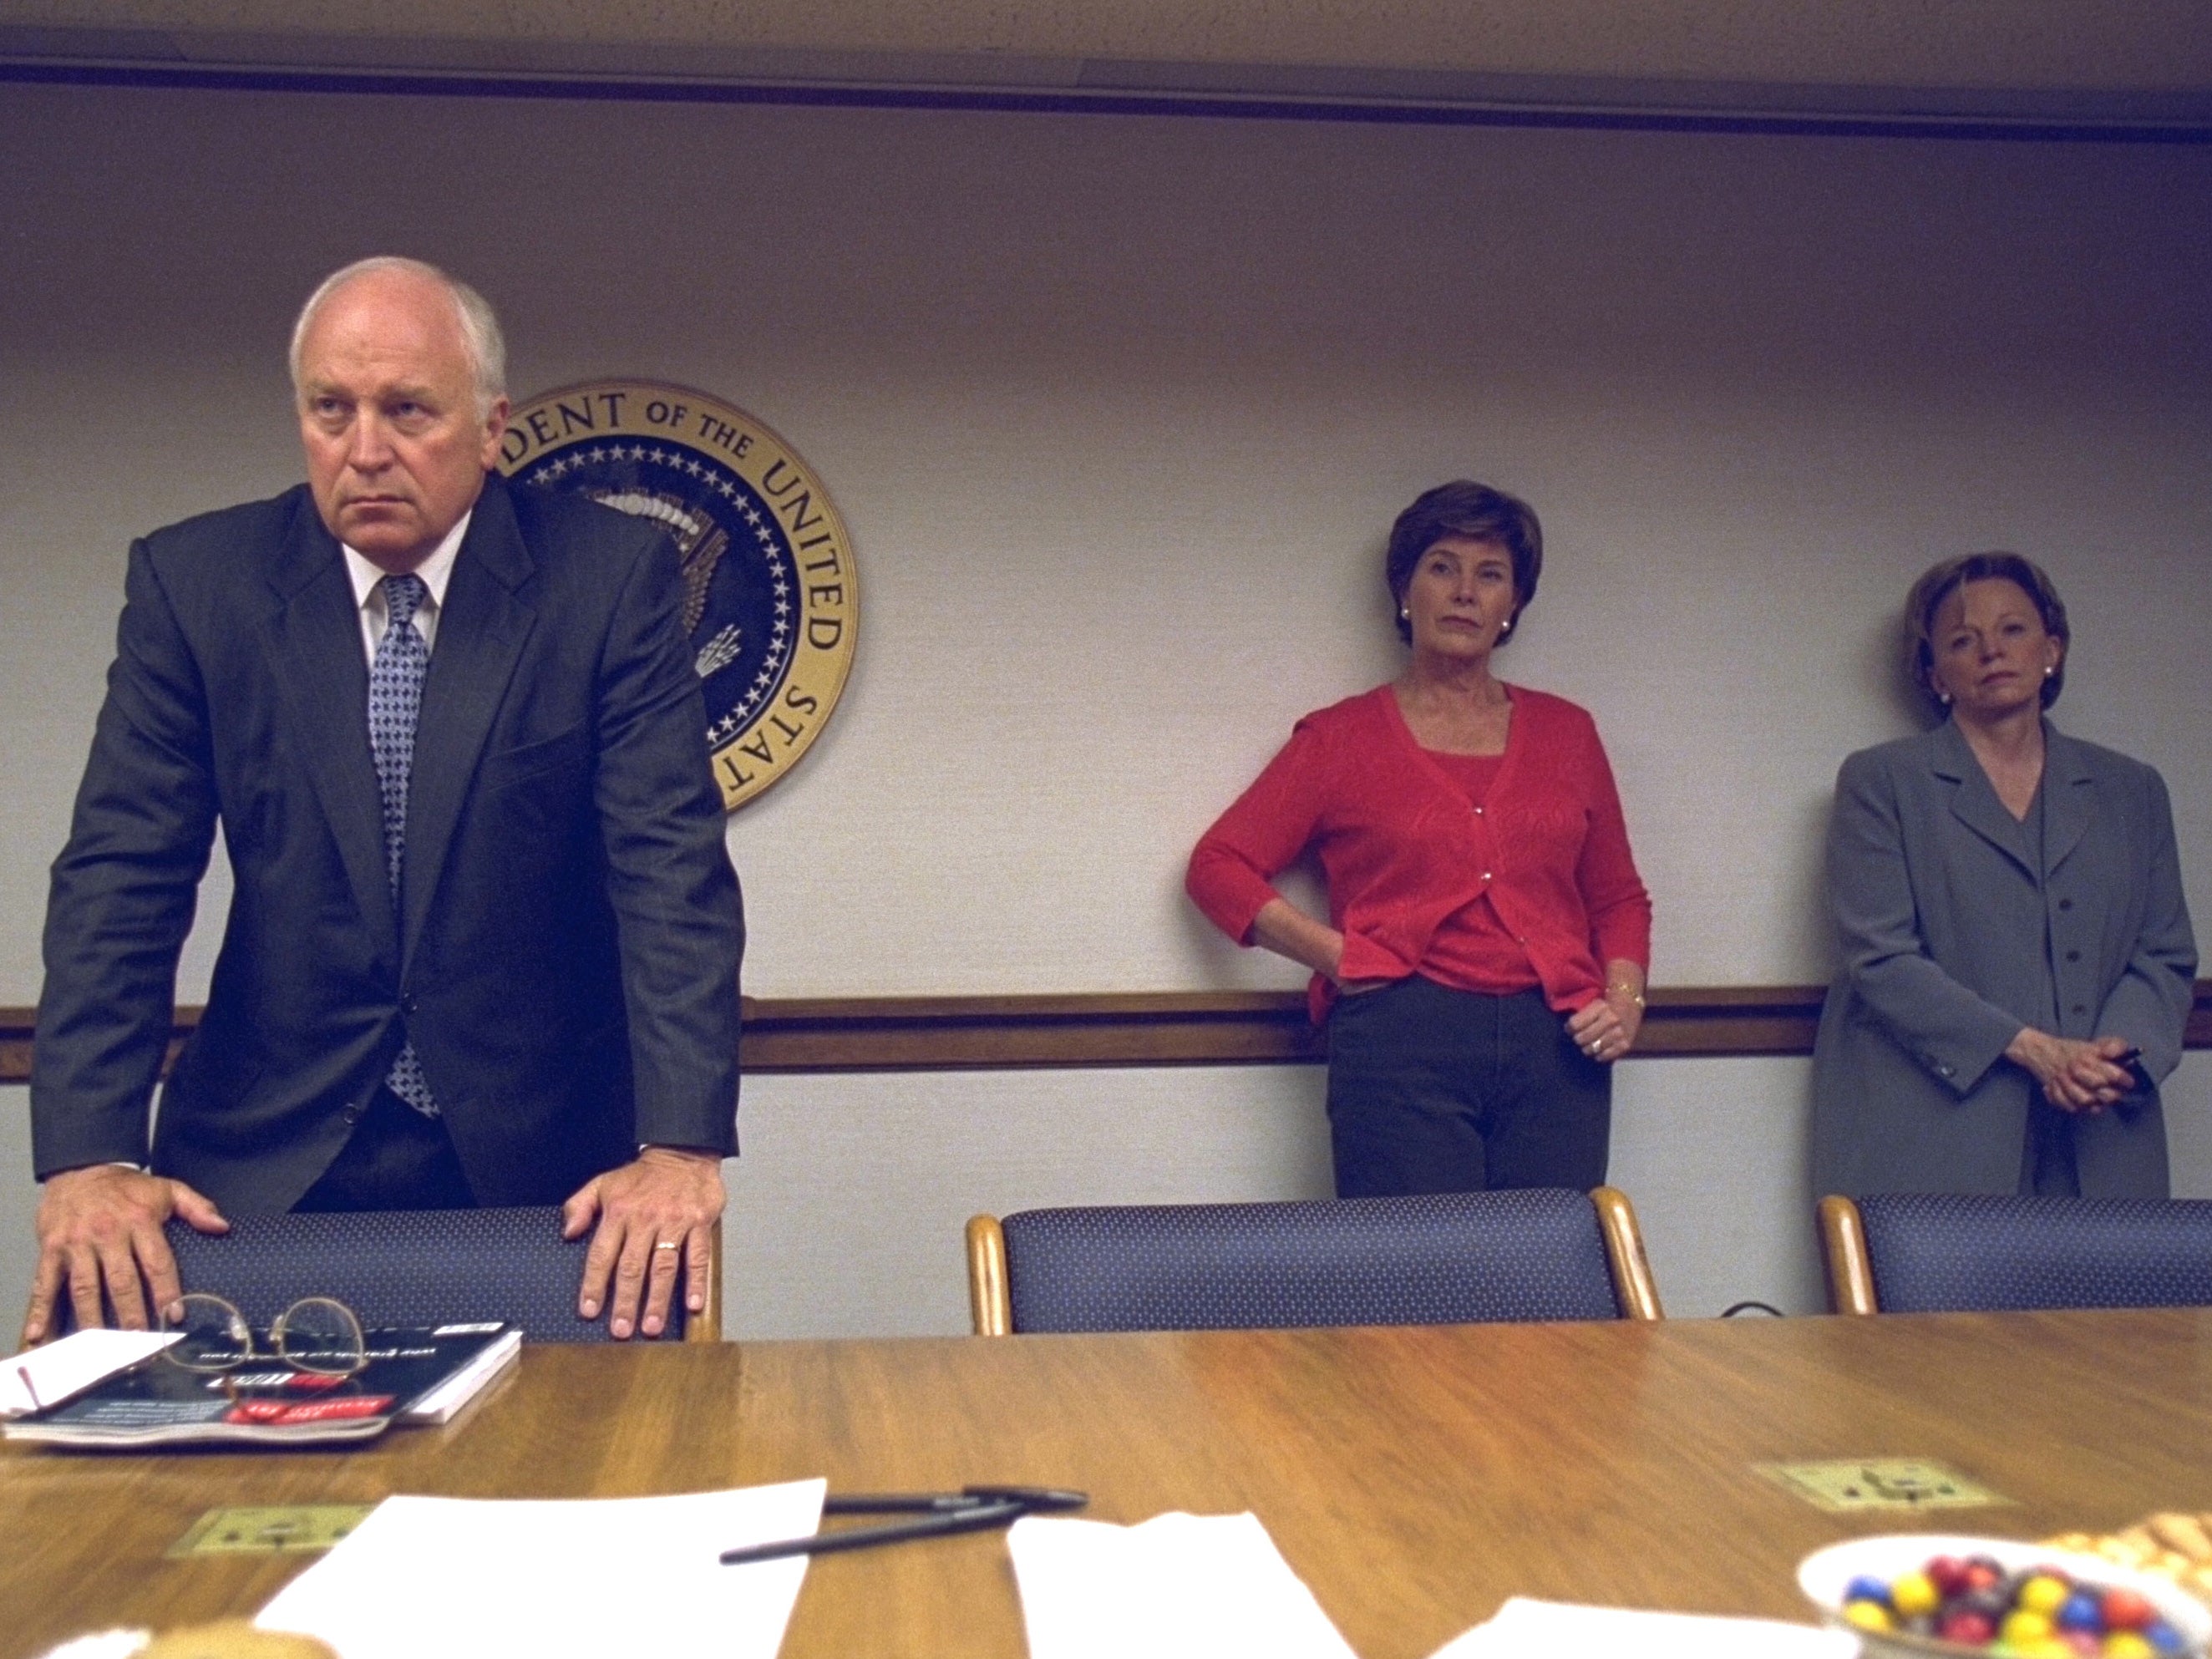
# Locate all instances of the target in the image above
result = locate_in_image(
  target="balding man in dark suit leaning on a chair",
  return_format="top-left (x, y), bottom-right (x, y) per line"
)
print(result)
top-left (24, 259), bottom-right (743, 1341)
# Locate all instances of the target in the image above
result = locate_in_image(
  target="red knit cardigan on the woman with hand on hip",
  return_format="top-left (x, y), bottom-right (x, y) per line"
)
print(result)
top-left (1185, 686), bottom-right (1652, 1024)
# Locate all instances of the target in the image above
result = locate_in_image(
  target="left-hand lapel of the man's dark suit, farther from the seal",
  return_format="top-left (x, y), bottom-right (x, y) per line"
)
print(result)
top-left (261, 491), bottom-right (398, 958)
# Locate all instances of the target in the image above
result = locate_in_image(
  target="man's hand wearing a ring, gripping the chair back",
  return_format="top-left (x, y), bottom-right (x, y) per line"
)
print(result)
top-left (562, 1146), bottom-right (723, 1338)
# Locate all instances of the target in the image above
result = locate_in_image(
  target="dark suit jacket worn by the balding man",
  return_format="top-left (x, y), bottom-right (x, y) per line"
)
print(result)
top-left (31, 478), bottom-right (743, 1210)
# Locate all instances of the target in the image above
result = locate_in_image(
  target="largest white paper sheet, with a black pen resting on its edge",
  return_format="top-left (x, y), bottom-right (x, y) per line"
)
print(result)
top-left (255, 1480), bottom-right (825, 1659)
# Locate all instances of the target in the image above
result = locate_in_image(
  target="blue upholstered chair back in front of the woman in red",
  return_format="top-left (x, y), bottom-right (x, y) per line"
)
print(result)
top-left (1002, 1188), bottom-right (1619, 1332)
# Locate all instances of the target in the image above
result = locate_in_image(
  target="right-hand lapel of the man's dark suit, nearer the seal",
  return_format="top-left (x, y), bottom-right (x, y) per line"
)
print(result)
top-left (400, 478), bottom-right (535, 962)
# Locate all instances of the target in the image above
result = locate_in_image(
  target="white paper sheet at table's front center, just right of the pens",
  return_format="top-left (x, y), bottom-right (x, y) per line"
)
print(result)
top-left (1008, 1513), bottom-right (1354, 1659)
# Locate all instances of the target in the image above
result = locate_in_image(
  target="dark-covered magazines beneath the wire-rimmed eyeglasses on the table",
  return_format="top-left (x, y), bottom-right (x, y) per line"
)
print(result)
top-left (4, 1323), bottom-right (522, 1451)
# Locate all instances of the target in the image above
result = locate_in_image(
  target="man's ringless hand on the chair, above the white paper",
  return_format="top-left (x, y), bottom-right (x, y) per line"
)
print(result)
top-left (22, 1164), bottom-right (230, 1347)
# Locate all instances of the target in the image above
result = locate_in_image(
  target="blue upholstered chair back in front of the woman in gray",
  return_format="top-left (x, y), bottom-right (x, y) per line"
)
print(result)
top-left (1858, 1192), bottom-right (2212, 1314)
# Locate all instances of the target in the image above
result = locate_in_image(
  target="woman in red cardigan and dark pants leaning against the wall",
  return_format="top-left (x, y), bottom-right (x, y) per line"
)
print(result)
top-left (1188, 480), bottom-right (1652, 1197)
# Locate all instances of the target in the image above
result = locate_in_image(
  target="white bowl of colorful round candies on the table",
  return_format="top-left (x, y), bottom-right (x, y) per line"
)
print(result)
top-left (1799, 1533), bottom-right (2212, 1659)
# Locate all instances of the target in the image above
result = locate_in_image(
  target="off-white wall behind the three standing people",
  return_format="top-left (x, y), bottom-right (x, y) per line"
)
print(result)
top-left (0, 86), bottom-right (2212, 1334)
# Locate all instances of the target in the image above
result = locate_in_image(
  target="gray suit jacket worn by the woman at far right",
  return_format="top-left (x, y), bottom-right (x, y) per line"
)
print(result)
top-left (1812, 721), bottom-right (2196, 1197)
